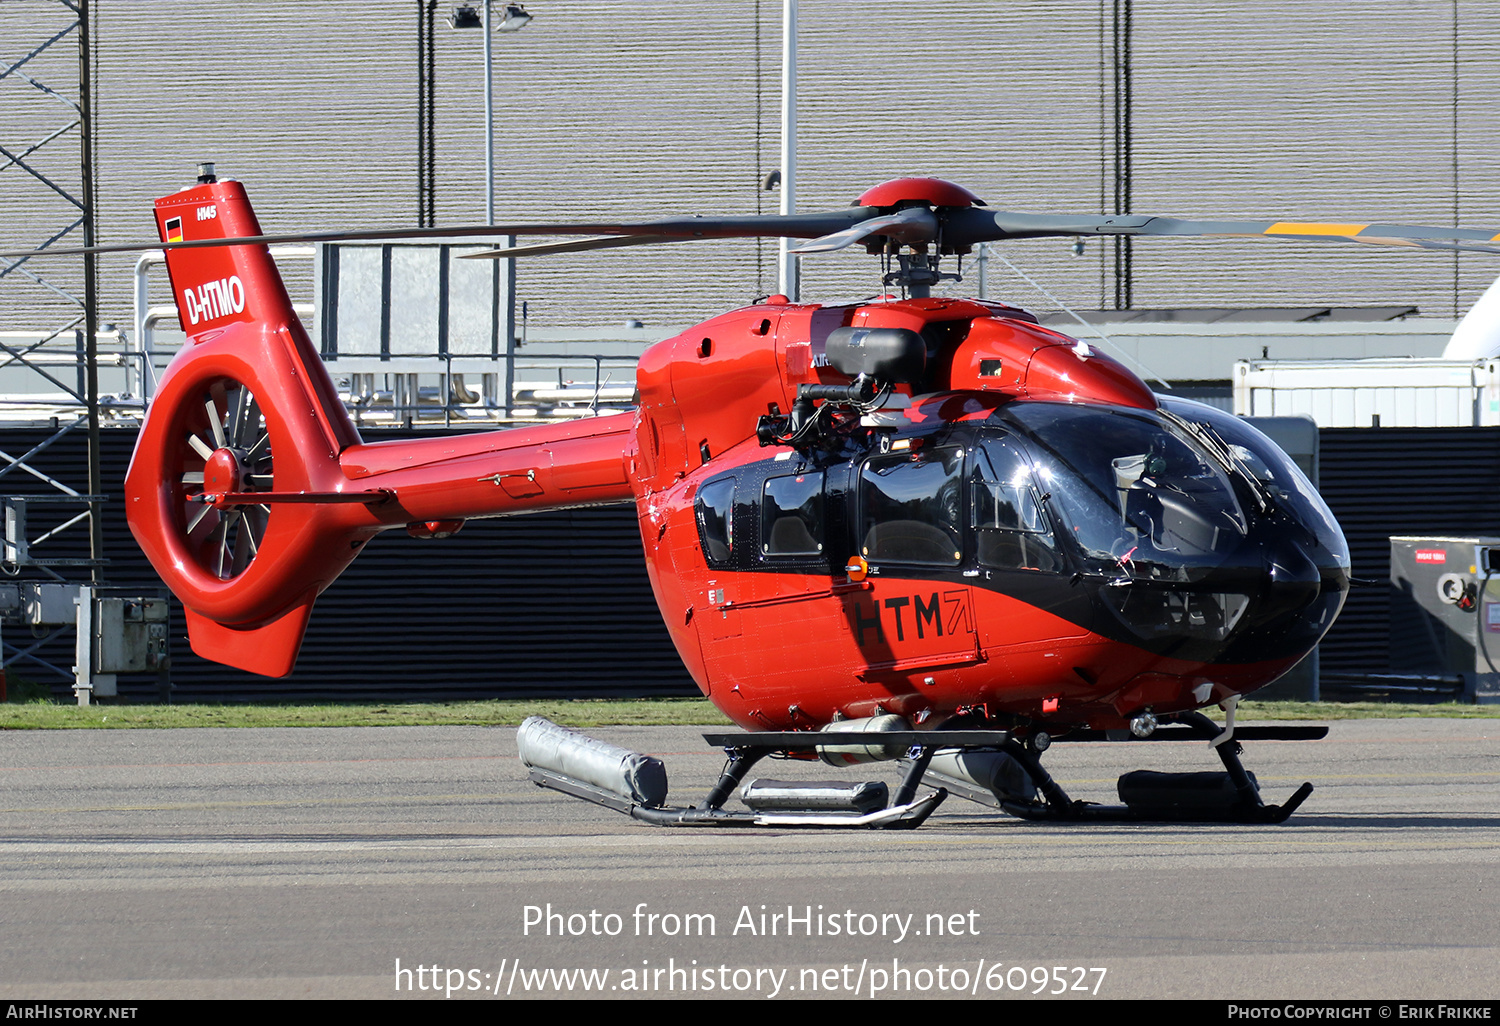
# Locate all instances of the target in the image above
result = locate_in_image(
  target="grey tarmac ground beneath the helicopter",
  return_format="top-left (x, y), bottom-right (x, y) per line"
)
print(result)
top-left (0, 720), bottom-right (1500, 1001)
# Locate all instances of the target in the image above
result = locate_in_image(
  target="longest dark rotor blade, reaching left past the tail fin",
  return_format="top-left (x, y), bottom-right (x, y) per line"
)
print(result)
top-left (0, 207), bottom-right (875, 258)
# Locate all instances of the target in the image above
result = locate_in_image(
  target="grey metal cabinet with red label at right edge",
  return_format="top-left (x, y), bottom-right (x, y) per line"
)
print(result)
top-left (1389, 537), bottom-right (1500, 702)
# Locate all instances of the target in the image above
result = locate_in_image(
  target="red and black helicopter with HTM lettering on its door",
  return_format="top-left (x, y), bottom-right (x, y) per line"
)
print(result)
top-left (58, 173), bottom-right (1500, 827)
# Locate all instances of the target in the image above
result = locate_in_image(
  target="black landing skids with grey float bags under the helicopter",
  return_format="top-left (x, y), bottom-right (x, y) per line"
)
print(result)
top-left (522, 713), bottom-right (1328, 830)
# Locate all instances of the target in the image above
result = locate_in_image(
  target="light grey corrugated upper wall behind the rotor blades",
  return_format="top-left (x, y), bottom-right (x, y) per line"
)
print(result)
top-left (0, 0), bottom-right (1500, 329)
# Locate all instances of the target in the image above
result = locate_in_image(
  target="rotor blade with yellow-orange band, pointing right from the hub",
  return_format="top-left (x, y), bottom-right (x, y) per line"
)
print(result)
top-left (944, 209), bottom-right (1500, 254)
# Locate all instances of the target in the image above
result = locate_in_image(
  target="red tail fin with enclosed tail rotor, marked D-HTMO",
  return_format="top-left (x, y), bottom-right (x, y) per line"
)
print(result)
top-left (126, 176), bottom-right (374, 677)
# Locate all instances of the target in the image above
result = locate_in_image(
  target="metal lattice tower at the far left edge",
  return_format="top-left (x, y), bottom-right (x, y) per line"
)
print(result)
top-left (0, 0), bottom-right (105, 687)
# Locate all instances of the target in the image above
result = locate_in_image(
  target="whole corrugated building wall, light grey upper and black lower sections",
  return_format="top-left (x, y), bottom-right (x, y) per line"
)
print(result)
top-left (0, 0), bottom-right (1500, 698)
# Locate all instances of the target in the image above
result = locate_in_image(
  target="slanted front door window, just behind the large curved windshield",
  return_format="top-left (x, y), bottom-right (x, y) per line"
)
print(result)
top-left (969, 438), bottom-right (1062, 570)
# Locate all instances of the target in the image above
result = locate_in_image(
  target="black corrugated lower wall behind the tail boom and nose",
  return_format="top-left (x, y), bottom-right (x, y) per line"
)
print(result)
top-left (0, 428), bottom-right (1500, 701)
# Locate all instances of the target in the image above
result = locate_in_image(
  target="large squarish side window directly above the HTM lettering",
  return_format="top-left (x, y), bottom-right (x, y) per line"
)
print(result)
top-left (860, 447), bottom-right (963, 567)
